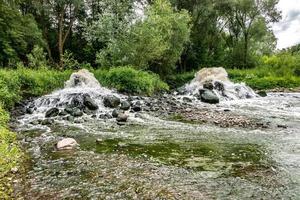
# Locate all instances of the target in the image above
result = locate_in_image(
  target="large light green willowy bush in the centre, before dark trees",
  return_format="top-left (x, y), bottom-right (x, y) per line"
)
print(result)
top-left (97, 0), bottom-right (190, 74)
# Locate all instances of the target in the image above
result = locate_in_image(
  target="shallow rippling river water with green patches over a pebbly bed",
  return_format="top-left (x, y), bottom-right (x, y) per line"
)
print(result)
top-left (13, 94), bottom-right (300, 199)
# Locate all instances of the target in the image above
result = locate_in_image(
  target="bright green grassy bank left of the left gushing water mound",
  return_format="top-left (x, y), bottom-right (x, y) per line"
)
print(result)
top-left (0, 68), bottom-right (71, 108)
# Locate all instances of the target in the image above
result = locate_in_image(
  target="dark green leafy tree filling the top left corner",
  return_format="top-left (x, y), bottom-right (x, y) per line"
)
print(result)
top-left (0, 1), bottom-right (43, 67)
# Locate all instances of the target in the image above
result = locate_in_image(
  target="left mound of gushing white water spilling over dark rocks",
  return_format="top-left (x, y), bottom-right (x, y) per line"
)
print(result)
top-left (25, 69), bottom-right (123, 121)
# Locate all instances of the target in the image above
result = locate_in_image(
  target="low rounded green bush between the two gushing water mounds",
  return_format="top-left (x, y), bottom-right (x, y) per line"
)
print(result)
top-left (94, 66), bottom-right (169, 95)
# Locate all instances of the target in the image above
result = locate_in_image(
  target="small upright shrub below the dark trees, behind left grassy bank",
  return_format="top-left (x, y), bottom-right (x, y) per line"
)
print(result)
top-left (27, 45), bottom-right (48, 69)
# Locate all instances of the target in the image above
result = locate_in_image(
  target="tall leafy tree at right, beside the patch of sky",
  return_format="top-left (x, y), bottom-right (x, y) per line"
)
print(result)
top-left (217, 0), bottom-right (281, 68)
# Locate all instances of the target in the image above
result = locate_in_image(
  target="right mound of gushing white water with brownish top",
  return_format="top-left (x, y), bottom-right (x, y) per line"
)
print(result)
top-left (184, 67), bottom-right (257, 100)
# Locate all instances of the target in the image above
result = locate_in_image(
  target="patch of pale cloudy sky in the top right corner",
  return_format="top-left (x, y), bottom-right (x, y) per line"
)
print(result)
top-left (272, 0), bottom-right (300, 49)
